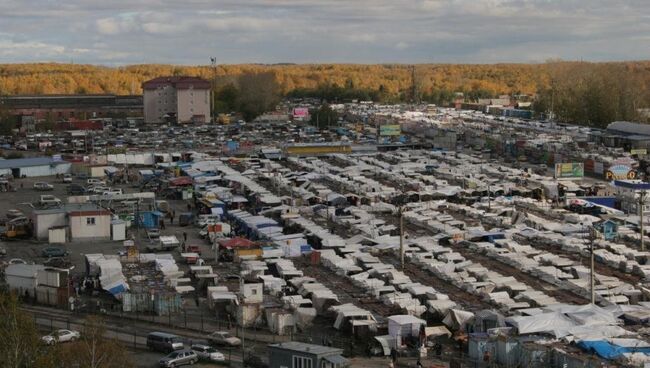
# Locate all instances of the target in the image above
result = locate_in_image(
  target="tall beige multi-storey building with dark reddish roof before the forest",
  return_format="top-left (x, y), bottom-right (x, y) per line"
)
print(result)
top-left (142, 77), bottom-right (210, 124)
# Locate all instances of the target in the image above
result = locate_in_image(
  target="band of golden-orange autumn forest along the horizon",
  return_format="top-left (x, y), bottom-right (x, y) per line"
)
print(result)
top-left (0, 61), bottom-right (650, 125)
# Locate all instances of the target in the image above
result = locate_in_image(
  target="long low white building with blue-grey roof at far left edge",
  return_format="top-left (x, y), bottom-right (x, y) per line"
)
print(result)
top-left (0, 157), bottom-right (72, 178)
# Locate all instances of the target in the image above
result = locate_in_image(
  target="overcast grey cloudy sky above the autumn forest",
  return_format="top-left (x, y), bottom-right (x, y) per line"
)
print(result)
top-left (0, 0), bottom-right (650, 65)
